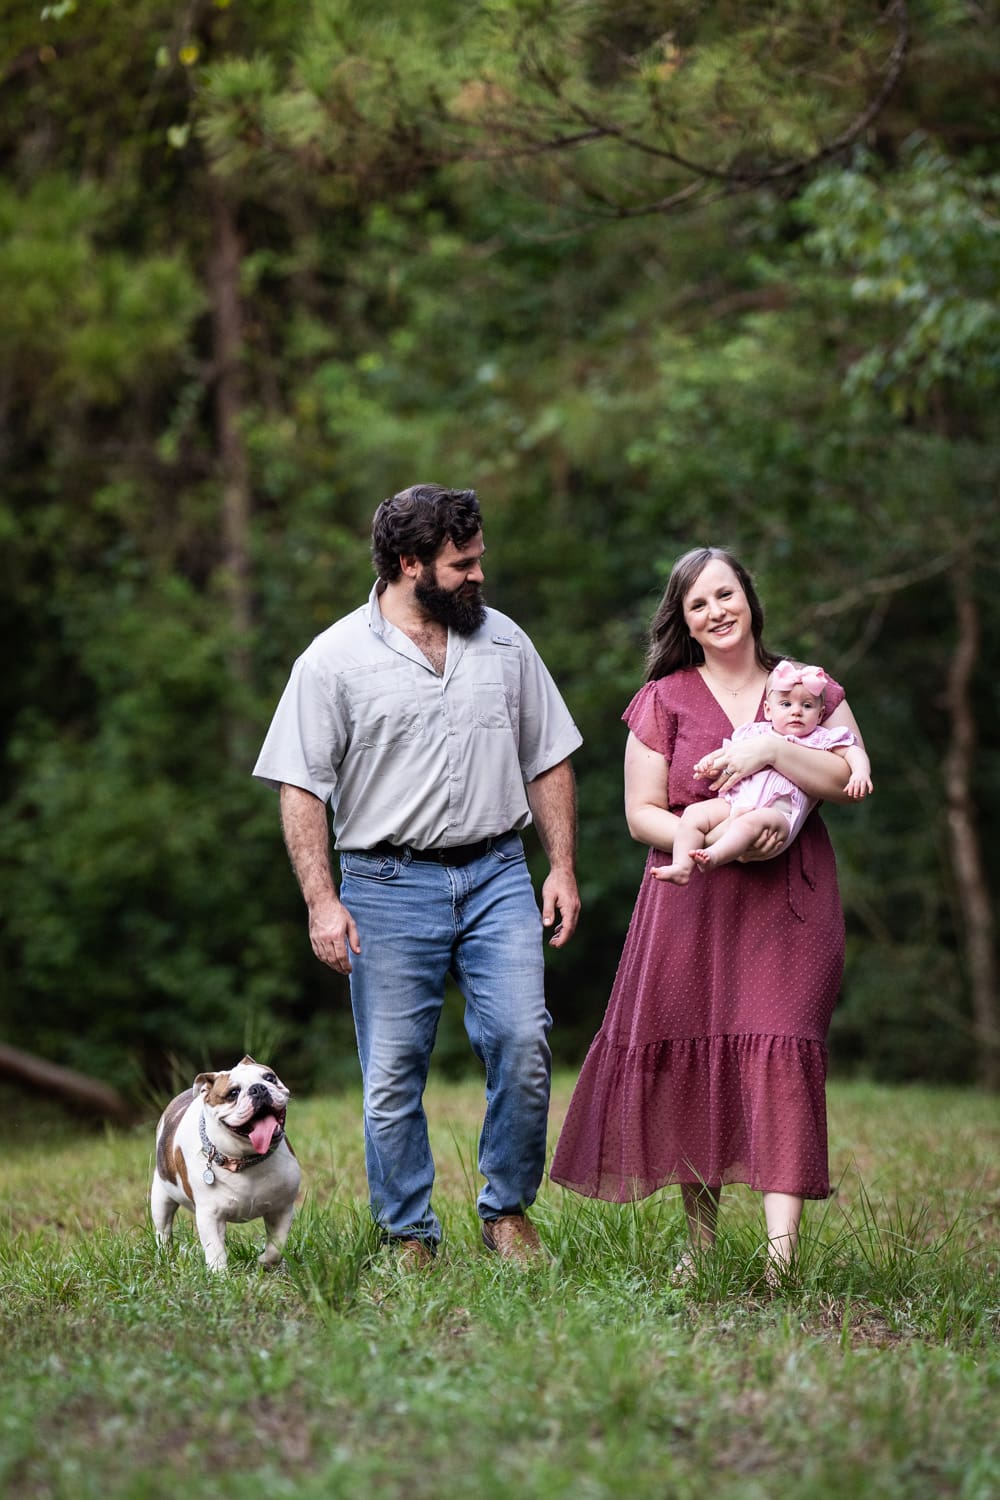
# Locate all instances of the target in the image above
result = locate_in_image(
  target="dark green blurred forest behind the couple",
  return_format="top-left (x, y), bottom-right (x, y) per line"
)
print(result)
top-left (0, 0), bottom-right (1000, 1094)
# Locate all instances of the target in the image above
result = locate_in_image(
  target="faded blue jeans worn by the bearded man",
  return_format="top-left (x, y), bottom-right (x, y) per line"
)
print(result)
top-left (340, 834), bottom-right (552, 1245)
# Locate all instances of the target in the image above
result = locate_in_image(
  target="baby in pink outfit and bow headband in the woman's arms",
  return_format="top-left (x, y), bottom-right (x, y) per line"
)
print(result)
top-left (651, 662), bottom-right (871, 885)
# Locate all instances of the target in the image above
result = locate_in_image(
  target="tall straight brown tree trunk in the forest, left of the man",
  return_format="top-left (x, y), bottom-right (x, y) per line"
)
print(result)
top-left (208, 176), bottom-right (253, 761)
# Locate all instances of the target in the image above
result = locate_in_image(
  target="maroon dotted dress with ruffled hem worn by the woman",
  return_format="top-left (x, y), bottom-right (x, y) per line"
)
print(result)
top-left (552, 668), bottom-right (844, 1203)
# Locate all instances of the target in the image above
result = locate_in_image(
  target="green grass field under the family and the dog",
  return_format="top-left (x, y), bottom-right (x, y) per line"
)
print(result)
top-left (0, 1077), bottom-right (1000, 1500)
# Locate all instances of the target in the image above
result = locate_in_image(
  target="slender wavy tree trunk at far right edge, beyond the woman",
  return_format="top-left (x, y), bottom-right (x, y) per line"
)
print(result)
top-left (945, 558), bottom-right (1000, 1091)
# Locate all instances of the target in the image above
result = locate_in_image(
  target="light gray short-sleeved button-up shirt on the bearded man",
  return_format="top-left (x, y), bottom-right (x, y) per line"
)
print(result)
top-left (253, 584), bottom-right (582, 849)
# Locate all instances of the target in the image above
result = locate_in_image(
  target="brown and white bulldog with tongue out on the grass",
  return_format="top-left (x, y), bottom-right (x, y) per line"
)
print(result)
top-left (150, 1058), bottom-right (301, 1271)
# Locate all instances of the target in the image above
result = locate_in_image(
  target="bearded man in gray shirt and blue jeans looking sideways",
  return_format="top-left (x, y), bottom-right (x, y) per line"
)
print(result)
top-left (253, 485), bottom-right (580, 1265)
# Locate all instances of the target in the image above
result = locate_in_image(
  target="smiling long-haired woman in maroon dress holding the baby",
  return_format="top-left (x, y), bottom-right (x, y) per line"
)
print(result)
top-left (552, 548), bottom-right (861, 1275)
